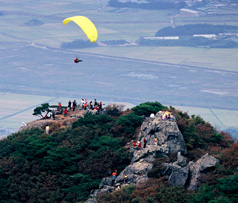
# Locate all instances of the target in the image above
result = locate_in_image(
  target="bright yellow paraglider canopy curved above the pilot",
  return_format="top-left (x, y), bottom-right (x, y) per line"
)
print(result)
top-left (63, 16), bottom-right (98, 43)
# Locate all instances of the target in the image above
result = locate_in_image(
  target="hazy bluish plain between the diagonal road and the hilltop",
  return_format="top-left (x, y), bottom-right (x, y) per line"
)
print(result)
top-left (0, 43), bottom-right (238, 139)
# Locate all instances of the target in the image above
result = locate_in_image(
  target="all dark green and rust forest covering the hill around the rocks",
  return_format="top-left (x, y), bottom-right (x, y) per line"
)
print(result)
top-left (0, 102), bottom-right (238, 203)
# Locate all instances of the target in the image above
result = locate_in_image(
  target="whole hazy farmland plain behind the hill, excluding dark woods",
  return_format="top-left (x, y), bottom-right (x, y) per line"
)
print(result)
top-left (0, 0), bottom-right (238, 138)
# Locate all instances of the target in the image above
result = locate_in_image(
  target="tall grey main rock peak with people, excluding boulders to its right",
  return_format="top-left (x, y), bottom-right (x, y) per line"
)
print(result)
top-left (116, 112), bottom-right (187, 184)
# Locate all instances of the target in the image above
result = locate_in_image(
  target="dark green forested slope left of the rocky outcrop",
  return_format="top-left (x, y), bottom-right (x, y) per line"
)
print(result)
top-left (0, 114), bottom-right (134, 202)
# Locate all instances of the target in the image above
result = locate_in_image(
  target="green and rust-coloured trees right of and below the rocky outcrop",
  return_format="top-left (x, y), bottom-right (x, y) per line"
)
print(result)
top-left (99, 103), bottom-right (238, 203)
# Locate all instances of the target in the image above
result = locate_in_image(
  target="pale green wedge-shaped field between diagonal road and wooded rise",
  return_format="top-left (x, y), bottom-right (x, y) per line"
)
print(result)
top-left (81, 46), bottom-right (238, 72)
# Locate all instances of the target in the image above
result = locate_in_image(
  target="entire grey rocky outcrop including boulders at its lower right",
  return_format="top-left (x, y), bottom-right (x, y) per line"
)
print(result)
top-left (86, 112), bottom-right (218, 203)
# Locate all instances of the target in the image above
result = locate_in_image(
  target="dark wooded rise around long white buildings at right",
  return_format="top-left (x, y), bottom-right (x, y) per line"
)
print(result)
top-left (138, 24), bottom-right (238, 48)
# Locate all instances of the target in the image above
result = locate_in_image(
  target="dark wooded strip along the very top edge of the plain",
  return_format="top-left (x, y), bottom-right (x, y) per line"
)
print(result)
top-left (108, 0), bottom-right (186, 10)
